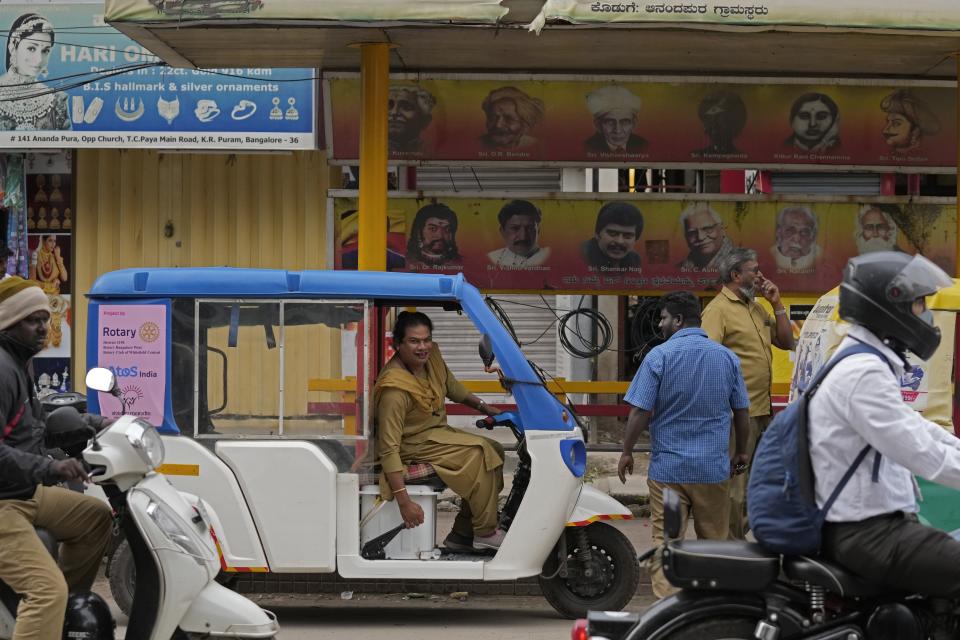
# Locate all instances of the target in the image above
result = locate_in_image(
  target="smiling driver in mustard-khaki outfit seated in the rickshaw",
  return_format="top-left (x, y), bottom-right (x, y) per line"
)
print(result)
top-left (373, 311), bottom-right (504, 553)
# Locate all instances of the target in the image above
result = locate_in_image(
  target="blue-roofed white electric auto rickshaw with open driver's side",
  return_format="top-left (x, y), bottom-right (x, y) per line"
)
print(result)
top-left (87, 268), bottom-right (639, 617)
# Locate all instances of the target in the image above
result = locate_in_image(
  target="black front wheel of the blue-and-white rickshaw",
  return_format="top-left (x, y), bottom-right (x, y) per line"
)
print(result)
top-left (540, 522), bottom-right (640, 618)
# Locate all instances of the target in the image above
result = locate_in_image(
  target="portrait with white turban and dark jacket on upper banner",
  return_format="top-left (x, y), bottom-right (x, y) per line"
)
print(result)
top-left (584, 85), bottom-right (647, 154)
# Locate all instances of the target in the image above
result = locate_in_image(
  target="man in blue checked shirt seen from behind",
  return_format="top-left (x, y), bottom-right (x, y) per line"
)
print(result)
top-left (617, 291), bottom-right (750, 598)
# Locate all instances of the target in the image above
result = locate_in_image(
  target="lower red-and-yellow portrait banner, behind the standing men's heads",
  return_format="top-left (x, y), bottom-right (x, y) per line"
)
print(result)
top-left (333, 196), bottom-right (957, 293)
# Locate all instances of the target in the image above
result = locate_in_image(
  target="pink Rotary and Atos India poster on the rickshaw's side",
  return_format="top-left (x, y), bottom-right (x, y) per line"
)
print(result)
top-left (97, 304), bottom-right (167, 426)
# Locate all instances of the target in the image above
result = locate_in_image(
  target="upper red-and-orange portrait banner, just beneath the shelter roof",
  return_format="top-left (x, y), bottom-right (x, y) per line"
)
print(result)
top-left (327, 75), bottom-right (957, 172)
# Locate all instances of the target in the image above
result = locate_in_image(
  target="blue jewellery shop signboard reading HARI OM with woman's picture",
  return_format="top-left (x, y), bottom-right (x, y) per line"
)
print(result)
top-left (0, 2), bottom-right (316, 149)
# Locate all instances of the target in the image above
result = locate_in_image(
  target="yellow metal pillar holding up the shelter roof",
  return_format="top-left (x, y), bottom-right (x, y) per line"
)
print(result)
top-left (358, 42), bottom-right (390, 271)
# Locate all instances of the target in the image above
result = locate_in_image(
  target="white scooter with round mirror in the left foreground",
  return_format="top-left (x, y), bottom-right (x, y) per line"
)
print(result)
top-left (0, 369), bottom-right (279, 640)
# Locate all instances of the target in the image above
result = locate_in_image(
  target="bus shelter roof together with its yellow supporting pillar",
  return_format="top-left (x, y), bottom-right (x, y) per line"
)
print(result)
top-left (105, 0), bottom-right (960, 269)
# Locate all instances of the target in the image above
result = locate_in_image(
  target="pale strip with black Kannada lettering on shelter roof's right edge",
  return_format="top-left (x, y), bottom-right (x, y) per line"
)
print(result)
top-left (531, 0), bottom-right (960, 31)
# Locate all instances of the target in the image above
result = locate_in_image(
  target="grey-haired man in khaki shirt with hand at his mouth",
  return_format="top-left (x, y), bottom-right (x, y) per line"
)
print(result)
top-left (702, 249), bottom-right (793, 540)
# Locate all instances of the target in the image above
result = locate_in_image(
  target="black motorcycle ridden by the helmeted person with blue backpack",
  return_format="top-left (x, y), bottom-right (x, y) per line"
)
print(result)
top-left (574, 489), bottom-right (960, 640)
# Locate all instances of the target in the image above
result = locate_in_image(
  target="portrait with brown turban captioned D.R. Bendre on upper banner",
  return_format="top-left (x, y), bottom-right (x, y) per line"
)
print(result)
top-left (480, 87), bottom-right (544, 151)
